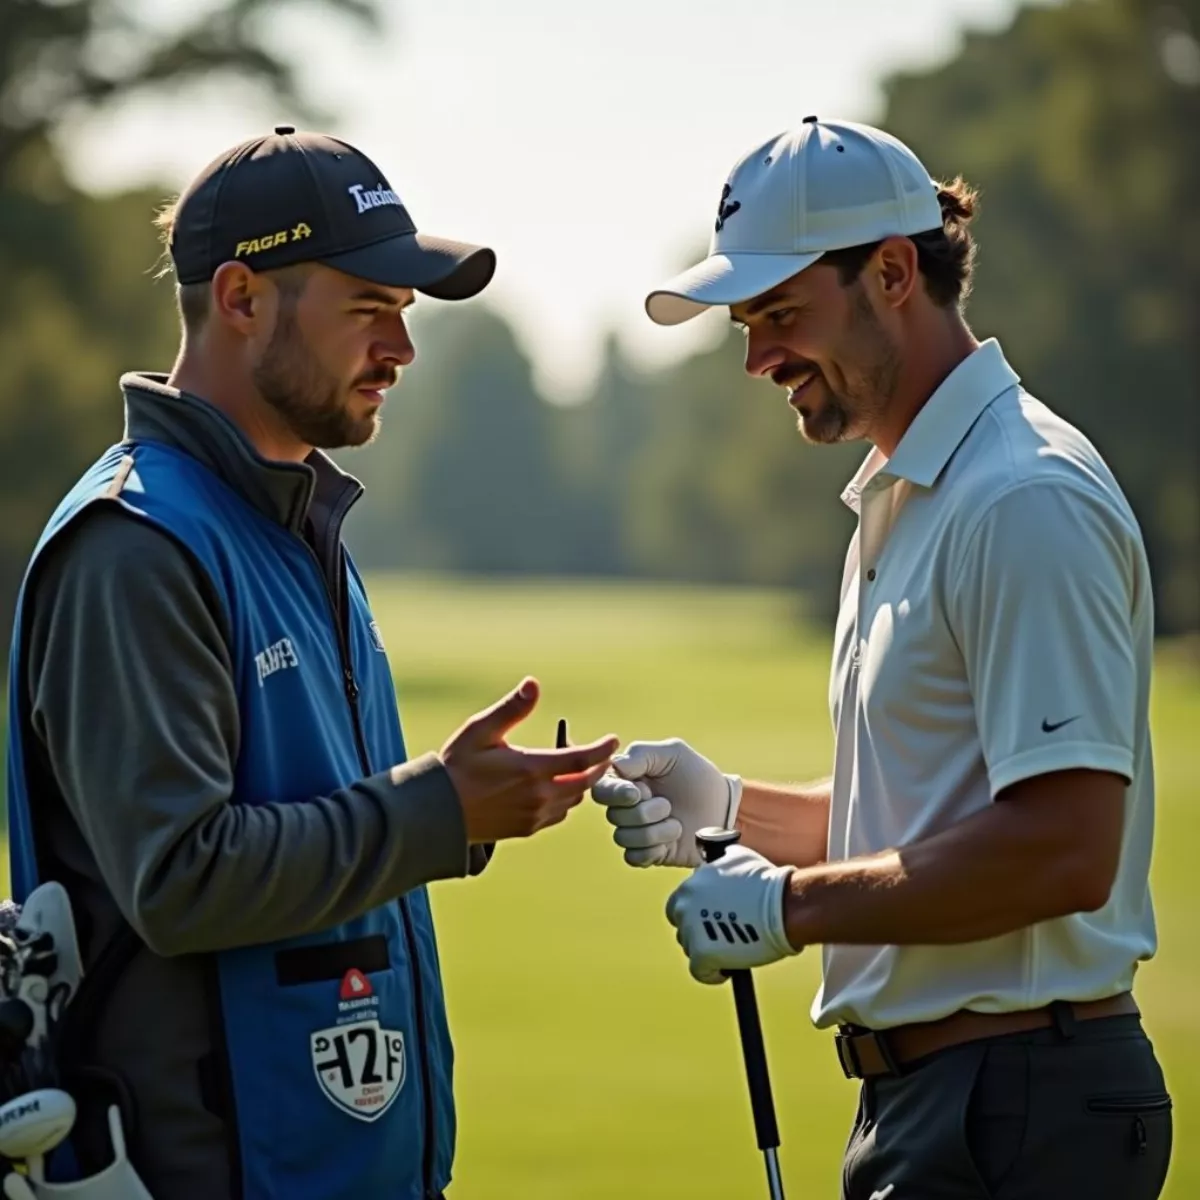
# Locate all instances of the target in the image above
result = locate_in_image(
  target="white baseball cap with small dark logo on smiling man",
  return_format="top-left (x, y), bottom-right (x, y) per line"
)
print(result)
top-left (646, 116), bottom-right (942, 325)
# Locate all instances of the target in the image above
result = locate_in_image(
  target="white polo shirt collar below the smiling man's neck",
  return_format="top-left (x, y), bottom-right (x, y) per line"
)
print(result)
top-left (841, 337), bottom-right (1020, 511)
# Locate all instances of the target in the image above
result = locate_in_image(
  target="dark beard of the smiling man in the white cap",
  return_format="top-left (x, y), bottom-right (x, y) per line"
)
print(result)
top-left (796, 289), bottom-right (900, 445)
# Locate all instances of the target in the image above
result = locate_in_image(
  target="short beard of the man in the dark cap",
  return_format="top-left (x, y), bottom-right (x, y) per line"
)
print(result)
top-left (253, 306), bottom-right (395, 450)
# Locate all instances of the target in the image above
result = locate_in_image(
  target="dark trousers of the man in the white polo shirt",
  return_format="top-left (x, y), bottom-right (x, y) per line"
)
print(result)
top-left (841, 1015), bottom-right (1172, 1200)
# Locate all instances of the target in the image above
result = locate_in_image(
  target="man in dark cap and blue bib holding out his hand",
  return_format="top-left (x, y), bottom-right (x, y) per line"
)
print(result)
top-left (8, 126), bottom-right (616, 1200)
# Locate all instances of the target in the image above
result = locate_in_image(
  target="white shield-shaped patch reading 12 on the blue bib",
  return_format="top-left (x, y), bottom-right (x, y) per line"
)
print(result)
top-left (310, 1020), bottom-right (407, 1121)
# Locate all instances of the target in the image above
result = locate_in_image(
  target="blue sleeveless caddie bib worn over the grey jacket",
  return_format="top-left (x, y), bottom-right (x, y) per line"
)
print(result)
top-left (7, 442), bottom-right (455, 1200)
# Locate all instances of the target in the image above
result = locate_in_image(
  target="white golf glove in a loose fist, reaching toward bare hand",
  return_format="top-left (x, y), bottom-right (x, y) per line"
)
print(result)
top-left (592, 738), bottom-right (742, 866)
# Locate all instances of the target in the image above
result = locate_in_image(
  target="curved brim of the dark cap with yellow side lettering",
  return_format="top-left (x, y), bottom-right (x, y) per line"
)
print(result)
top-left (320, 233), bottom-right (496, 300)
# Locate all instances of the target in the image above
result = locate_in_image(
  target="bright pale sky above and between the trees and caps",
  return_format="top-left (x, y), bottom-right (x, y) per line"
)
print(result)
top-left (62, 0), bottom-right (1051, 400)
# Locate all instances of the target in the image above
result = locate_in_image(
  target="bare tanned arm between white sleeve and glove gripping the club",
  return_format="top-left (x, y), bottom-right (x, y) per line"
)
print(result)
top-left (785, 782), bottom-right (1103, 946)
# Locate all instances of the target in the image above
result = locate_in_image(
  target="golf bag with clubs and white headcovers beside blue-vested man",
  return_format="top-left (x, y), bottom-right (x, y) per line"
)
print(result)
top-left (0, 882), bottom-right (152, 1200)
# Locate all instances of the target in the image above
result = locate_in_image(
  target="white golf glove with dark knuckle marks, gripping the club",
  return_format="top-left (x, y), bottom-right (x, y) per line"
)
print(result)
top-left (667, 846), bottom-right (800, 983)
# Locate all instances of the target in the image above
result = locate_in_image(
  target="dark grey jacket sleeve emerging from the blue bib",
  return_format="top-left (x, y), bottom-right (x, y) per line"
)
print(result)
top-left (26, 506), bottom-right (472, 954)
